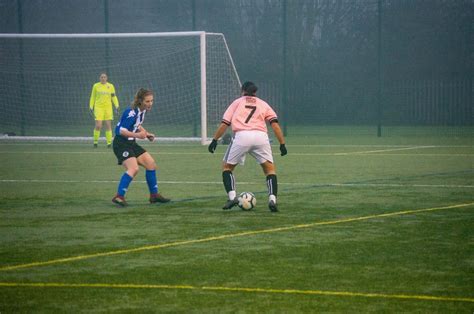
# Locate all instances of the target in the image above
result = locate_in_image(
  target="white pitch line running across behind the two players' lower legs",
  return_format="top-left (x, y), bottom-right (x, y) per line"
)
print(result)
top-left (0, 179), bottom-right (474, 188)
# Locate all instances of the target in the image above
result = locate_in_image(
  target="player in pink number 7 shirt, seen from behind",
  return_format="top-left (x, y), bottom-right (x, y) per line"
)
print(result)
top-left (208, 82), bottom-right (287, 212)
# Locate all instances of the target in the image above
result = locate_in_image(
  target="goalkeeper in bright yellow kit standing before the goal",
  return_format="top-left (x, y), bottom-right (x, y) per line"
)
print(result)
top-left (89, 73), bottom-right (119, 148)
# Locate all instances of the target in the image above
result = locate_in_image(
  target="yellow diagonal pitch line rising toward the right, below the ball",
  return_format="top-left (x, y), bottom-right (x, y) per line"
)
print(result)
top-left (0, 203), bottom-right (474, 271)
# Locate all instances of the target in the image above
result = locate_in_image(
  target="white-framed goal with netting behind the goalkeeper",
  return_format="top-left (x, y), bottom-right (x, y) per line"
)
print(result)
top-left (0, 32), bottom-right (240, 143)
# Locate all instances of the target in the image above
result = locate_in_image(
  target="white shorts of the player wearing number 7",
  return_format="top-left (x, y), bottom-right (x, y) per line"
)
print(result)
top-left (223, 131), bottom-right (273, 165)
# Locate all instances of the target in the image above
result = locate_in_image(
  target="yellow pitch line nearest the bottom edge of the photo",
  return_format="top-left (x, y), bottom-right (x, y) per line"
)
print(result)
top-left (0, 282), bottom-right (474, 303)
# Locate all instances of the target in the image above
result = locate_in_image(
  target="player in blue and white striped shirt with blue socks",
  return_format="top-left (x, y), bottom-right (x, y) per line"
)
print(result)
top-left (112, 88), bottom-right (170, 206)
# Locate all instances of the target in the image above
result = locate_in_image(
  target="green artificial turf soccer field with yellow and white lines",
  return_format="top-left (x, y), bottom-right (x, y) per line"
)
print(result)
top-left (0, 135), bottom-right (474, 313)
